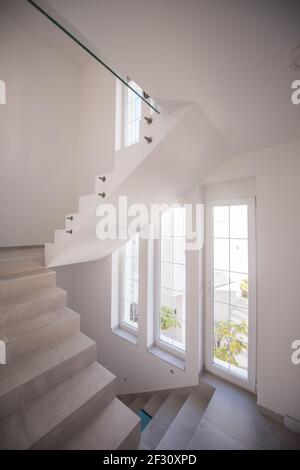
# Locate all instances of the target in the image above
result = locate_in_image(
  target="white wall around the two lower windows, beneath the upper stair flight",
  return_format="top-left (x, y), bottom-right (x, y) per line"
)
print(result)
top-left (56, 188), bottom-right (203, 393)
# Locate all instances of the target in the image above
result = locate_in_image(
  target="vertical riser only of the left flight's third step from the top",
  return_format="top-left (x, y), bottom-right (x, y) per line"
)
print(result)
top-left (0, 291), bottom-right (67, 329)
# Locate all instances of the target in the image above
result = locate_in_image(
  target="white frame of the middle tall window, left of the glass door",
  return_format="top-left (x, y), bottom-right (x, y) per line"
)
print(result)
top-left (154, 206), bottom-right (187, 359)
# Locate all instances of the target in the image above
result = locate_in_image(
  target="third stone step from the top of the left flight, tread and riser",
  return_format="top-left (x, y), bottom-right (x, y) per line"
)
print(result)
top-left (0, 287), bottom-right (67, 329)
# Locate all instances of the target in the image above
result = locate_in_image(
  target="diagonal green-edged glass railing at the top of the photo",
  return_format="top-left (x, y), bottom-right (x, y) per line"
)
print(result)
top-left (27, 0), bottom-right (161, 114)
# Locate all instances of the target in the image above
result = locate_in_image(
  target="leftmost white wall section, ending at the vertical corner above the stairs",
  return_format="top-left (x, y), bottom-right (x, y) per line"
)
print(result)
top-left (0, 14), bottom-right (80, 246)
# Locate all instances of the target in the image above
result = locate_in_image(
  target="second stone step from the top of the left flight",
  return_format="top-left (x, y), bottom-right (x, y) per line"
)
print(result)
top-left (0, 269), bottom-right (56, 300)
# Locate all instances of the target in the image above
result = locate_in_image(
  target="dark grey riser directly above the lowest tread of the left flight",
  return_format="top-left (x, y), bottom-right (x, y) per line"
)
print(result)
top-left (31, 378), bottom-right (117, 450)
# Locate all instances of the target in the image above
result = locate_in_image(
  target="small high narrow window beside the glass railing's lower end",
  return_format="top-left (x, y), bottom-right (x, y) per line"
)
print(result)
top-left (125, 80), bottom-right (142, 145)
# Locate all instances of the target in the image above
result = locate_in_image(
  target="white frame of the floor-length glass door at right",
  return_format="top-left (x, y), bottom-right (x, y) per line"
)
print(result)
top-left (205, 197), bottom-right (256, 392)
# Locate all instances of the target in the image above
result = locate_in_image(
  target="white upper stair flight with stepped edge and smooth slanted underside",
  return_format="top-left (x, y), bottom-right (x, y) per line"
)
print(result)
top-left (45, 103), bottom-right (231, 267)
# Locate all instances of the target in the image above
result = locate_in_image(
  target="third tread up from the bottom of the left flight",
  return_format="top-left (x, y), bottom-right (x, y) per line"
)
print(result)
top-left (0, 332), bottom-right (95, 397)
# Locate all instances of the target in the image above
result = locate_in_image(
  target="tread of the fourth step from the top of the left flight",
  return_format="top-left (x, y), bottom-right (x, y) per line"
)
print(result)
top-left (0, 307), bottom-right (80, 342)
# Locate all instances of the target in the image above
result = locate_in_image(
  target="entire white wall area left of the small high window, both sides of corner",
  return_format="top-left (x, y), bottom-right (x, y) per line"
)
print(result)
top-left (0, 11), bottom-right (115, 246)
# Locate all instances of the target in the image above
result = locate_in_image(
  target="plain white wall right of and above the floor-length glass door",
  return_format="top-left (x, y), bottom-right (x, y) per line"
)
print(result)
top-left (205, 142), bottom-right (300, 419)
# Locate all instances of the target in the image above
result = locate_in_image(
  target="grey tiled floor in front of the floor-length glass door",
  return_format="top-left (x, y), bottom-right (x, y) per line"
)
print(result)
top-left (197, 373), bottom-right (300, 449)
